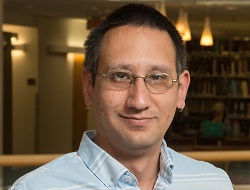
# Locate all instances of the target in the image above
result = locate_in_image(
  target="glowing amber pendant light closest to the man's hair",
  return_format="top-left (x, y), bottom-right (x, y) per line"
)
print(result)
top-left (175, 9), bottom-right (191, 41)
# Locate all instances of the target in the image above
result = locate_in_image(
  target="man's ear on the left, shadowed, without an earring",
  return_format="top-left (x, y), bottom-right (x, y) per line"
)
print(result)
top-left (82, 71), bottom-right (93, 107)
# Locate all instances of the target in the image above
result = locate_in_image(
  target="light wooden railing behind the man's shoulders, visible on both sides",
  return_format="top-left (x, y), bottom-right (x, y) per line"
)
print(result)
top-left (0, 150), bottom-right (250, 167)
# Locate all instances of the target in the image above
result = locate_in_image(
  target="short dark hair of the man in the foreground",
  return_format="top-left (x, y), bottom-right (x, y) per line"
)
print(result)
top-left (84, 3), bottom-right (187, 82)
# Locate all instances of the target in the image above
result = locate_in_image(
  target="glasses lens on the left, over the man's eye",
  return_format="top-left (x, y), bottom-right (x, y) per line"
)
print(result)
top-left (106, 71), bottom-right (133, 90)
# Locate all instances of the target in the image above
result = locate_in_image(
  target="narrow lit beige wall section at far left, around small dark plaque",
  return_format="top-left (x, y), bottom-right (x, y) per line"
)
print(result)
top-left (3, 24), bottom-right (38, 154)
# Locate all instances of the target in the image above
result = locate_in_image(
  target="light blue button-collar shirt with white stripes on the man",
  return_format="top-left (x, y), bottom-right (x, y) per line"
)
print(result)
top-left (10, 131), bottom-right (233, 190)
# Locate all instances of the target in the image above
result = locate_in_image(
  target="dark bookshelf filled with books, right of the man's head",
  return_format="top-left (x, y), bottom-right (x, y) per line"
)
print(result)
top-left (169, 36), bottom-right (250, 145)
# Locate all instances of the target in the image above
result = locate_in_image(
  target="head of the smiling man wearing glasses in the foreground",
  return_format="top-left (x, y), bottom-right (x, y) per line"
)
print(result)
top-left (83, 4), bottom-right (190, 158)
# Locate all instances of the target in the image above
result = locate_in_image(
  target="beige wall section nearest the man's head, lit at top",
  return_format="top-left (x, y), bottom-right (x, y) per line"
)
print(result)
top-left (38, 18), bottom-right (88, 153)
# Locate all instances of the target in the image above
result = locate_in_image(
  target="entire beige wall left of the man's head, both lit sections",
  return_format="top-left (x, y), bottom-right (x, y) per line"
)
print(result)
top-left (5, 15), bottom-right (91, 153)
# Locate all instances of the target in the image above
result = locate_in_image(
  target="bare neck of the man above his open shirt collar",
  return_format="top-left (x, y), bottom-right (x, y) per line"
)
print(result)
top-left (95, 134), bottom-right (162, 190)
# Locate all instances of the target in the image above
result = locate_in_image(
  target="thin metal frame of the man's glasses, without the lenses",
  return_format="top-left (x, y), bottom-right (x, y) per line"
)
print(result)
top-left (93, 70), bottom-right (179, 93)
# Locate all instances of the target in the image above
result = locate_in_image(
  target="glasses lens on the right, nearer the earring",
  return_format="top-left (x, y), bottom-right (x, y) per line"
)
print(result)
top-left (146, 73), bottom-right (173, 92)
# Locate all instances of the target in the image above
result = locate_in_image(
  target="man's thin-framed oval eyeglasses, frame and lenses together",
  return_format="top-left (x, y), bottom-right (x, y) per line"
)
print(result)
top-left (94, 70), bottom-right (178, 93)
